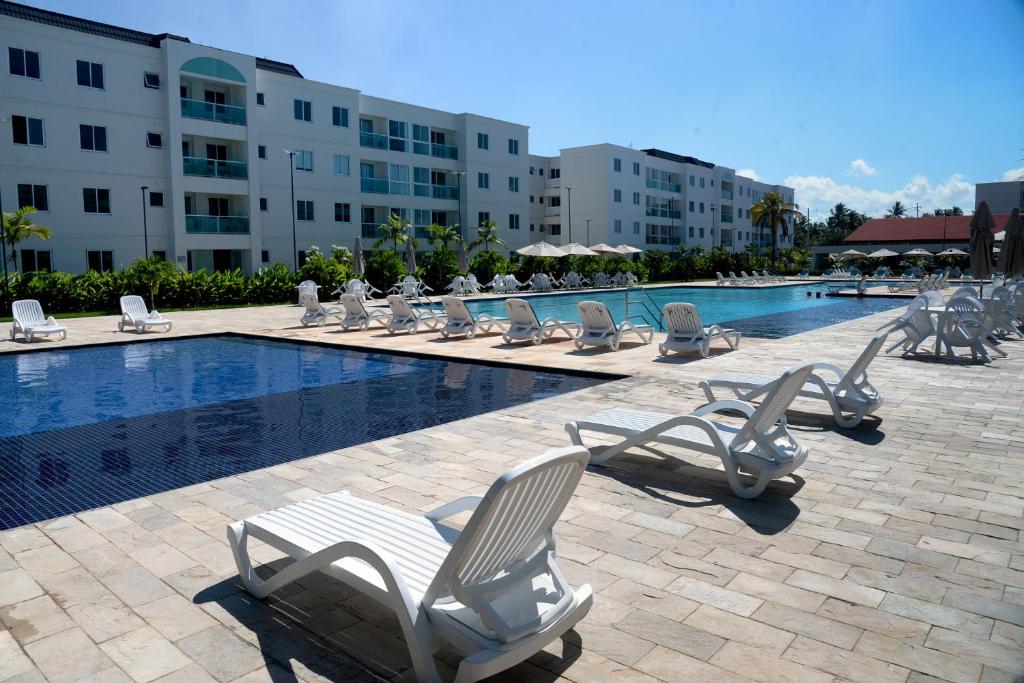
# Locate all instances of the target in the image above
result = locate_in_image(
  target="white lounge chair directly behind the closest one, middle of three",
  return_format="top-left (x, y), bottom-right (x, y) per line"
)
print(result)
top-left (565, 362), bottom-right (814, 498)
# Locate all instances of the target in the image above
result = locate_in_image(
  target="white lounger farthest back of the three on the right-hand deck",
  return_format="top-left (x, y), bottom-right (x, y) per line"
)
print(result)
top-left (698, 332), bottom-right (889, 428)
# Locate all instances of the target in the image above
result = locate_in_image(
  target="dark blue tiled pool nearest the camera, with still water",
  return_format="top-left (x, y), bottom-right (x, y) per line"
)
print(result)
top-left (0, 336), bottom-right (607, 529)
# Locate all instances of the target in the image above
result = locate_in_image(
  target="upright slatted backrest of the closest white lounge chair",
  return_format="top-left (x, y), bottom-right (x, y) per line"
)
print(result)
top-left (423, 446), bottom-right (588, 642)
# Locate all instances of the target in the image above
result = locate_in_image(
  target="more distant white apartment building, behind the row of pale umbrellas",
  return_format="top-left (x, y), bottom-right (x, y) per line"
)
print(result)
top-left (529, 144), bottom-right (794, 251)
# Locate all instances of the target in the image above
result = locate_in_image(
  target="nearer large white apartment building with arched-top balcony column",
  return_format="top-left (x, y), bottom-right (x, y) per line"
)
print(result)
top-left (0, 0), bottom-right (531, 272)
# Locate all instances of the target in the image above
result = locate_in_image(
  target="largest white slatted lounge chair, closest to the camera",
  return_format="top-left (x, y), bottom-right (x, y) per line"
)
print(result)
top-left (227, 447), bottom-right (593, 683)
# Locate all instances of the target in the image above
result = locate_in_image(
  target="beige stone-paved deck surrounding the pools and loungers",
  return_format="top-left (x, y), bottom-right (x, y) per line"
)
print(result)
top-left (0, 299), bottom-right (1024, 683)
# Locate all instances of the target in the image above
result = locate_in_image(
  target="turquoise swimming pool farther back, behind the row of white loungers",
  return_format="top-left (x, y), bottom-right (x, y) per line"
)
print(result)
top-left (467, 283), bottom-right (906, 339)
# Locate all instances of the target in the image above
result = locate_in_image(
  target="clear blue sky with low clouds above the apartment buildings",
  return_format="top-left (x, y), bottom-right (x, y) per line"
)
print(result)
top-left (29, 0), bottom-right (1024, 218)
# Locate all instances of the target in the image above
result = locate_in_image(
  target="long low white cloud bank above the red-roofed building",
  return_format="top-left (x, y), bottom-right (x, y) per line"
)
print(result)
top-left (783, 173), bottom-right (974, 219)
